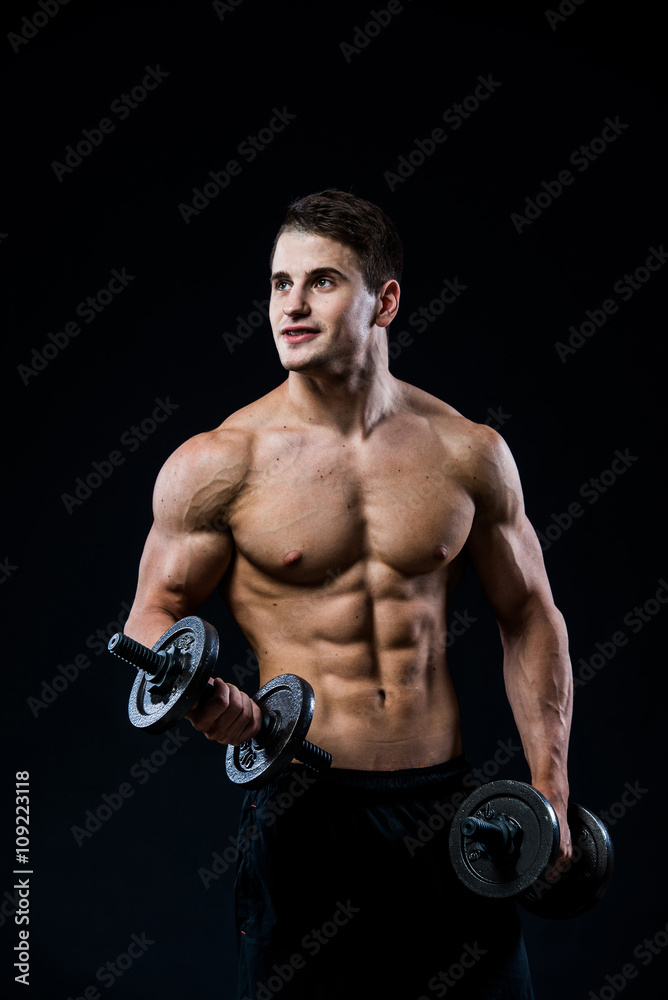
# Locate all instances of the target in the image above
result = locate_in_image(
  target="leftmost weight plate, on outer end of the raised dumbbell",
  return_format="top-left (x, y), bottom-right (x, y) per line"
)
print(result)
top-left (128, 616), bottom-right (218, 733)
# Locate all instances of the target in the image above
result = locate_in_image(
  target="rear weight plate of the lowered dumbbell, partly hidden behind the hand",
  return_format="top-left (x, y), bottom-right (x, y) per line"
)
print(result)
top-left (517, 803), bottom-right (613, 920)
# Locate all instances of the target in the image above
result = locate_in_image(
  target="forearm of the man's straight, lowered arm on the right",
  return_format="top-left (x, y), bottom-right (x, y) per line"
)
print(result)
top-left (501, 608), bottom-right (573, 797)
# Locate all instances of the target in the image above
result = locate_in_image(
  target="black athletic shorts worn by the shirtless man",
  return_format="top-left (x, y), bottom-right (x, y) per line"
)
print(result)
top-left (235, 757), bottom-right (533, 1000)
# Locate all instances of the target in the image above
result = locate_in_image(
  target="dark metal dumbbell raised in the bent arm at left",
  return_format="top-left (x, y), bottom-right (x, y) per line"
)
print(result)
top-left (107, 615), bottom-right (332, 788)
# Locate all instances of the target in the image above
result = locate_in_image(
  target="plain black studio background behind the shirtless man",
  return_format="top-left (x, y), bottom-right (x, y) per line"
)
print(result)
top-left (0, 0), bottom-right (668, 1000)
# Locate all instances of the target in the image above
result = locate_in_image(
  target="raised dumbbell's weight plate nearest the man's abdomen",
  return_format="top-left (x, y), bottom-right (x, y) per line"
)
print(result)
top-left (225, 674), bottom-right (315, 788)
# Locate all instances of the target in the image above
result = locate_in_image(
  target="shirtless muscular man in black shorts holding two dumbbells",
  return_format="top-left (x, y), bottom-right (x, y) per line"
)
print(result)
top-left (126, 191), bottom-right (572, 1000)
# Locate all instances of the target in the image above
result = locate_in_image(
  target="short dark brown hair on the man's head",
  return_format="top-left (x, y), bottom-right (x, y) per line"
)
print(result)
top-left (270, 188), bottom-right (404, 292)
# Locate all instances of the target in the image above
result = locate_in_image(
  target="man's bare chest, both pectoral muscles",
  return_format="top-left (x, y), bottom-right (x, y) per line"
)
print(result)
top-left (231, 440), bottom-right (474, 584)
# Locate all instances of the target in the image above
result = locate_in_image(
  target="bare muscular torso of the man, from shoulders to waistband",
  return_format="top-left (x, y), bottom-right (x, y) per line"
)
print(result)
top-left (221, 386), bottom-right (475, 770)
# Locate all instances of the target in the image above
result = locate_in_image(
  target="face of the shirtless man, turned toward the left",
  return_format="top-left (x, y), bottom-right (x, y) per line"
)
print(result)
top-left (269, 230), bottom-right (379, 374)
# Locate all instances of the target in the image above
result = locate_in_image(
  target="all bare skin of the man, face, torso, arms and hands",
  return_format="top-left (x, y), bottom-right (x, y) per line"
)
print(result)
top-left (125, 230), bottom-right (572, 868)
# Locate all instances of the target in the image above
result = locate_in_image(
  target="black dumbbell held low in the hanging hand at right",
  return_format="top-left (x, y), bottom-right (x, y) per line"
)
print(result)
top-left (449, 780), bottom-right (613, 920)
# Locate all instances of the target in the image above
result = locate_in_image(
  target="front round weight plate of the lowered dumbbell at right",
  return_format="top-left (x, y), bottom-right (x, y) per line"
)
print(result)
top-left (450, 780), bottom-right (559, 899)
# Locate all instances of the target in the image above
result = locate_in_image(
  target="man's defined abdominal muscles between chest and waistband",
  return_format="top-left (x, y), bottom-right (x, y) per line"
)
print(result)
top-left (223, 553), bottom-right (461, 770)
